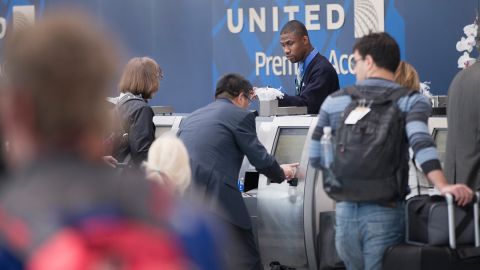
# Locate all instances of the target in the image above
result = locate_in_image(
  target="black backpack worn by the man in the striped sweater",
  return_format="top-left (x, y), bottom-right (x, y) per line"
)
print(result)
top-left (324, 86), bottom-right (415, 202)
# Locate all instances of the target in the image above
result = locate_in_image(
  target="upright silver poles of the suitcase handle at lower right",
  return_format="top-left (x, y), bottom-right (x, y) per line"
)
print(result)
top-left (445, 191), bottom-right (480, 249)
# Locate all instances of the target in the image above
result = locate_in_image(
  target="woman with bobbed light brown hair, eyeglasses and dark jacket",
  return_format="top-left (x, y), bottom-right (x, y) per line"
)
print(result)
top-left (105, 57), bottom-right (163, 168)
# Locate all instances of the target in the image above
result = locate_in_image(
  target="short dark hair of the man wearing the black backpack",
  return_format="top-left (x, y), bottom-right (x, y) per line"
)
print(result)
top-left (353, 32), bottom-right (400, 72)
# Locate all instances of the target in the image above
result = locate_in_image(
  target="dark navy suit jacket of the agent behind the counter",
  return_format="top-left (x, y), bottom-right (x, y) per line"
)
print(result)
top-left (278, 53), bottom-right (340, 114)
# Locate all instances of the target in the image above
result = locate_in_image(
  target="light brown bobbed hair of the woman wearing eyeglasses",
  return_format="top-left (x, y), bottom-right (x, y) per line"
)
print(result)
top-left (118, 57), bottom-right (163, 99)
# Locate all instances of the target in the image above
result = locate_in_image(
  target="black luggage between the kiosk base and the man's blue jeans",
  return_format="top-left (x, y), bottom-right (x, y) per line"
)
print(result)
top-left (317, 211), bottom-right (345, 270)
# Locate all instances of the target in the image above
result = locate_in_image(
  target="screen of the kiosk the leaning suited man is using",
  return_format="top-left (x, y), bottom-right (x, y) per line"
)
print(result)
top-left (273, 127), bottom-right (308, 164)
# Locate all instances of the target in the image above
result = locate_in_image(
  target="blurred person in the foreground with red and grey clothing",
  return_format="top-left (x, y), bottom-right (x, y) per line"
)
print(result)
top-left (0, 11), bottom-right (221, 269)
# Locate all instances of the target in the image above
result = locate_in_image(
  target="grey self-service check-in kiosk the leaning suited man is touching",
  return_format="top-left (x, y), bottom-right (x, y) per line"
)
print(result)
top-left (240, 116), bottom-right (334, 269)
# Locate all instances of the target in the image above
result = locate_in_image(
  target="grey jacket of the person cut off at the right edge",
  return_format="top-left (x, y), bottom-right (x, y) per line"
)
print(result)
top-left (445, 63), bottom-right (480, 189)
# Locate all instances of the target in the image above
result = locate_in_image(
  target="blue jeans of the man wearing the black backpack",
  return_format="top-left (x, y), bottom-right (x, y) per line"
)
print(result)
top-left (335, 202), bottom-right (405, 270)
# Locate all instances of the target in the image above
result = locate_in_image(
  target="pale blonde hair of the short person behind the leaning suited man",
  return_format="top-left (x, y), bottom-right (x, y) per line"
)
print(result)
top-left (143, 134), bottom-right (191, 194)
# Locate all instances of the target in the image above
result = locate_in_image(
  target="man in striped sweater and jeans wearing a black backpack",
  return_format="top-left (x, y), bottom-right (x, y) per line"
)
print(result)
top-left (310, 33), bottom-right (473, 270)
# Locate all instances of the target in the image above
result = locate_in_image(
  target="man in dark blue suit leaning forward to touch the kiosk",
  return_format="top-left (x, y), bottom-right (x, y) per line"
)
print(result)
top-left (178, 74), bottom-right (298, 269)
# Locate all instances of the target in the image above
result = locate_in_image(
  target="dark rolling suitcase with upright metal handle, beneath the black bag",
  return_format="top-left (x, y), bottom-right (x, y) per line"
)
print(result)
top-left (383, 192), bottom-right (480, 270)
